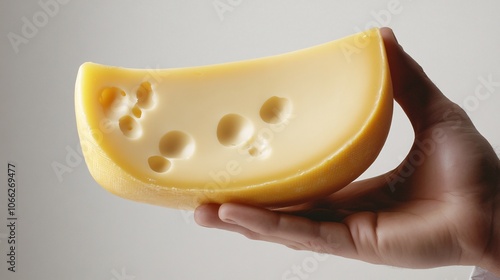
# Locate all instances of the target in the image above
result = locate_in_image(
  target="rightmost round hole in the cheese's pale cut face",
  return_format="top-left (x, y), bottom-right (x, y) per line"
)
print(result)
top-left (260, 96), bottom-right (292, 124)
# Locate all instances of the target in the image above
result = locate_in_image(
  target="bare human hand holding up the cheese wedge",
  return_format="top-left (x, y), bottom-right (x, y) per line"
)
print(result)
top-left (195, 28), bottom-right (500, 276)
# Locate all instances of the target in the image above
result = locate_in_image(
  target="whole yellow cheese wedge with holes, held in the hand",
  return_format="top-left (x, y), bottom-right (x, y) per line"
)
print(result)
top-left (75, 29), bottom-right (393, 209)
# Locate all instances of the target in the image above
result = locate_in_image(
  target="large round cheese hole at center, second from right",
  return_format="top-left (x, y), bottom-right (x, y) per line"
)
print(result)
top-left (217, 114), bottom-right (253, 147)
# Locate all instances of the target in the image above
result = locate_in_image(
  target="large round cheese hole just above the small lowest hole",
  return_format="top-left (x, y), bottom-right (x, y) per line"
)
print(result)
top-left (159, 130), bottom-right (195, 159)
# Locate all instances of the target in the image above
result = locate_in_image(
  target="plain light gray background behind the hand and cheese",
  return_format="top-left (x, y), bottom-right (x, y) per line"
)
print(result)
top-left (0, 0), bottom-right (500, 280)
